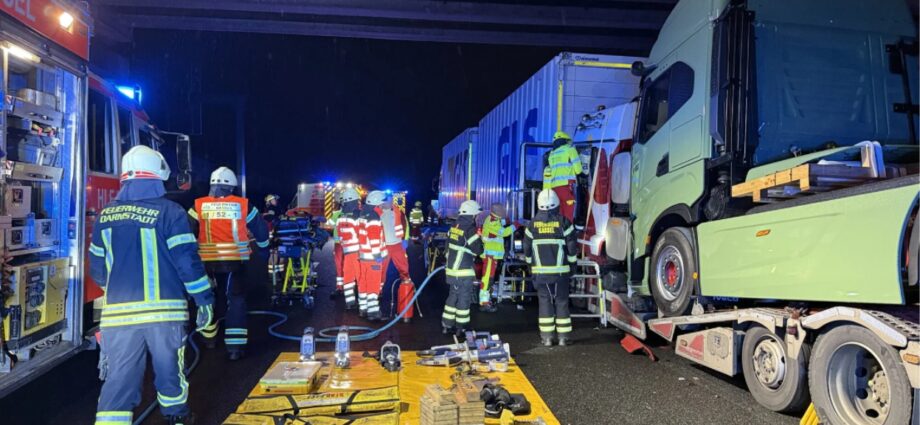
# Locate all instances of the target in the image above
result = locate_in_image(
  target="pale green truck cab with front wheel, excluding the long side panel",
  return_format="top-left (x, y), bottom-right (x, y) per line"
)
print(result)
top-left (623, 0), bottom-right (917, 314)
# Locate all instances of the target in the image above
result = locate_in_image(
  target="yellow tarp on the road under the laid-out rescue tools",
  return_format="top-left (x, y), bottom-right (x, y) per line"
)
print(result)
top-left (226, 351), bottom-right (559, 425)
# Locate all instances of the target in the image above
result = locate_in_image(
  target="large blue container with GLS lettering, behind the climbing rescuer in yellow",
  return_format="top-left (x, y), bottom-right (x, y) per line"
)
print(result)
top-left (472, 52), bottom-right (644, 220)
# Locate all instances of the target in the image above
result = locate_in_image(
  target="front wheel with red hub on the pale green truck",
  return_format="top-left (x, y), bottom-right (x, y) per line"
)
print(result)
top-left (649, 227), bottom-right (697, 316)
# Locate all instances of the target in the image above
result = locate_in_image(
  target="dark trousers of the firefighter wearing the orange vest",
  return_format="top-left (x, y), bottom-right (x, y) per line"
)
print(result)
top-left (201, 261), bottom-right (249, 351)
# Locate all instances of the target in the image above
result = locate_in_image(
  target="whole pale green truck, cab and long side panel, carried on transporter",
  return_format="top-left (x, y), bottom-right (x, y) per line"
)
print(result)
top-left (620, 0), bottom-right (918, 316)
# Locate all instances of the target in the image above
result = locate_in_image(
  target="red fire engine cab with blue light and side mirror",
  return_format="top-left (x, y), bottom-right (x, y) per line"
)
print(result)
top-left (84, 73), bottom-right (191, 308)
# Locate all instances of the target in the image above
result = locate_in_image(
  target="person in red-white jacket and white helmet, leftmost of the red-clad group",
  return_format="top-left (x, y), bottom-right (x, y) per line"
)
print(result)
top-left (335, 188), bottom-right (361, 310)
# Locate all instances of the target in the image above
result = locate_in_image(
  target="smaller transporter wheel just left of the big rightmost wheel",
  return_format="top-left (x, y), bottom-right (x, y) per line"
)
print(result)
top-left (741, 326), bottom-right (811, 413)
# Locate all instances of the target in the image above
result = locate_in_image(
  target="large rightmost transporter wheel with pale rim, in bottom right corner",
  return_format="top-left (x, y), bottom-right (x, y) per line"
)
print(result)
top-left (808, 325), bottom-right (912, 425)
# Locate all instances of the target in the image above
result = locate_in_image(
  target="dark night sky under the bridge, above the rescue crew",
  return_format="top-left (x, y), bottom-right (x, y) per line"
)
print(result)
top-left (131, 31), bottom-right (608, 204)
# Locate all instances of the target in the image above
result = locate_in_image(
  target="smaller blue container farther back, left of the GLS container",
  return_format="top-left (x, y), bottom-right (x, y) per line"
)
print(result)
top-left (438, 127), bottom-right (479, 218)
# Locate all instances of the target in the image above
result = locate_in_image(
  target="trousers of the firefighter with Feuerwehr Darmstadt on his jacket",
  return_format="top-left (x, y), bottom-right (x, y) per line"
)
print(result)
top-left (96, 323), bottom-right (189, 425)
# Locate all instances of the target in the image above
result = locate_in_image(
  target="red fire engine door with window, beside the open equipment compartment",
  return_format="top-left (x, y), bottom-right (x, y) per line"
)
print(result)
top-left (83, 89), bottom-right (121, 302)
